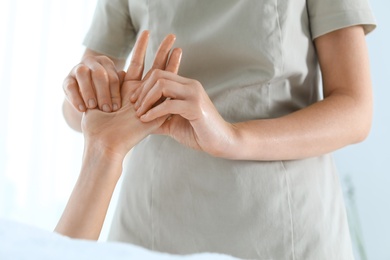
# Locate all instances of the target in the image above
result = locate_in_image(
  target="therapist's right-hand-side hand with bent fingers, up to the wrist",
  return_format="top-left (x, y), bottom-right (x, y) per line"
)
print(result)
top-left (135, 70), bottom-right (235, 157)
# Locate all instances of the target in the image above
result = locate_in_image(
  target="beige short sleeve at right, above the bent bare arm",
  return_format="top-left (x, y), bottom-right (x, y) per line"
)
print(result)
top-left (307, 0), bottom-right (376, 39)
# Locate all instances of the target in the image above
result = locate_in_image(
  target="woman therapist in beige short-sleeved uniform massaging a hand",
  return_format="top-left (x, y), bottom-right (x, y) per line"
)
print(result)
top-left (64, 0), bottom-right (375, 259)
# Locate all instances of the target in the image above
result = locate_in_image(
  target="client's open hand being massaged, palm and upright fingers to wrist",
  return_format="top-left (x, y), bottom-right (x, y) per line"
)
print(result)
top-left (81, 32), bottom-right (181, 159)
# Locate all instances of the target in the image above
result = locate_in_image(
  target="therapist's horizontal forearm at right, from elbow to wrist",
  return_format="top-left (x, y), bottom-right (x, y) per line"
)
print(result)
top-left (227, 91), bottom-right (372, 160)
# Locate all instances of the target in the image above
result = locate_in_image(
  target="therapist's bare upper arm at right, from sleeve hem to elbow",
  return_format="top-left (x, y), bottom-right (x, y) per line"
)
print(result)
top-left (314, 26), bottom-right (372, 136)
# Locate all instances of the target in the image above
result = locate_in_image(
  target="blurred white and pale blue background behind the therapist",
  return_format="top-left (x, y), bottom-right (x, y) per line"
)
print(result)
top-left (0, 0), bottom-right (390, 260)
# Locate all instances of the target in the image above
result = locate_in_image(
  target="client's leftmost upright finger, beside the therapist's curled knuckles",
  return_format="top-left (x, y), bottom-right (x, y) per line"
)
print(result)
top-left (125, 31), bottom-right (149, 81)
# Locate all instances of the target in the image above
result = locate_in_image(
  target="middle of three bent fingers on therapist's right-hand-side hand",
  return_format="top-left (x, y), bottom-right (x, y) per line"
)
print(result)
top-left (135, 79), bottom-right (192, 116)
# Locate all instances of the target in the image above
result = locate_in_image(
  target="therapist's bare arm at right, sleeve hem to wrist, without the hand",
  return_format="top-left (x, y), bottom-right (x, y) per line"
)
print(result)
top-left (229, 27), bottom-right (372, 160)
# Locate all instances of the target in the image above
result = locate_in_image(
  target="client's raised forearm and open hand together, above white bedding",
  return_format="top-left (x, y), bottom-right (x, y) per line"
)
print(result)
top-left (55, 32), bottom-right (181, 240)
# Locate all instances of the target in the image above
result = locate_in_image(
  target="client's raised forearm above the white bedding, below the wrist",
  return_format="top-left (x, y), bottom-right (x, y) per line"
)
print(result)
top-left (55, 142), bottom-right (122, 240)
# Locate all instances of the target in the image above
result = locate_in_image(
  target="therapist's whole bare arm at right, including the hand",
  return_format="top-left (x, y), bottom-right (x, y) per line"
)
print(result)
top-left (132, 26), bottom-right (372, 160)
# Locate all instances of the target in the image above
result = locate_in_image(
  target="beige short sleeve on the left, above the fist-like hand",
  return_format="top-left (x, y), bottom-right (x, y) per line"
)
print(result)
top-left (83, 0), bottom-right (136, 59)
